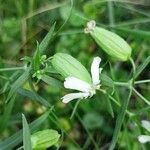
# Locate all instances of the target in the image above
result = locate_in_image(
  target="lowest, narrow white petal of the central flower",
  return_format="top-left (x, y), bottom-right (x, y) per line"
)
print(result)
top-left (62, 92), bottom-right (89, 103)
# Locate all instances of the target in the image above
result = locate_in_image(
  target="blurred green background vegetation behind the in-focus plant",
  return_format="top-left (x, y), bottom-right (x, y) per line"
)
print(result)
top-left (0, 0), bottom-right (150, 150)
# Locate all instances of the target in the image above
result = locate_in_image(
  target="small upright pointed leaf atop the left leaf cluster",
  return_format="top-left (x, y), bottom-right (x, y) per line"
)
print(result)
top-left (33, 42), bottom-right (40, 71)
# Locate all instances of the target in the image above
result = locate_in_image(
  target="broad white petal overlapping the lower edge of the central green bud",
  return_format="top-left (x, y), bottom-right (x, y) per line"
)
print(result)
top-left (64, 77), bottom-right (91, 92)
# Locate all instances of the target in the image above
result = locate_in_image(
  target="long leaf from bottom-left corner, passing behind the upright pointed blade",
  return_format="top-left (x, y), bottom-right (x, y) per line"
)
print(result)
top-left (0, 111), bottom-right (50, 150)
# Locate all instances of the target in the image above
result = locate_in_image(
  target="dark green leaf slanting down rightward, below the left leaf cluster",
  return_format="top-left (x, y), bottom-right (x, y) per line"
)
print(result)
top-left (17, 88), bottom-right (51, 107)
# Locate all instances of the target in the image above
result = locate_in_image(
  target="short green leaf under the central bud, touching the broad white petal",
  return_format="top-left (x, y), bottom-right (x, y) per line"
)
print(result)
top-left (41, 75), bottom-right (63, 88)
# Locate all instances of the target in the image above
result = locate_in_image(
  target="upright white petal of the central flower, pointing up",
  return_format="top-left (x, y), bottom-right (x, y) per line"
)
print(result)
top-left (91, 57), bottom-right (102, 85)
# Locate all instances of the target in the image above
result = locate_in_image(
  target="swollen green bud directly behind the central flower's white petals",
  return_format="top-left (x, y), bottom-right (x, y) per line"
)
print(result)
top-left (51, 53), bottom-right (92, 83)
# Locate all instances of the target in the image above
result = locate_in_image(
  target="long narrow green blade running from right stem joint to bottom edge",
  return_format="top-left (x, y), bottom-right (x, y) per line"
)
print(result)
top-left (109, 88), bottom-right (132, 150)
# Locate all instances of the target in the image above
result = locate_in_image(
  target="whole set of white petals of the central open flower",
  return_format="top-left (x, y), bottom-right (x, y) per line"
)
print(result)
top-left (62, 57), bottom-right (102, 103)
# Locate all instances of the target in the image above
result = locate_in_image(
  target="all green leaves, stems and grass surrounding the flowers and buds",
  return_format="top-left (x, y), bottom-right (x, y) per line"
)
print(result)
top-left (0, 0), bottom-right (150, 150)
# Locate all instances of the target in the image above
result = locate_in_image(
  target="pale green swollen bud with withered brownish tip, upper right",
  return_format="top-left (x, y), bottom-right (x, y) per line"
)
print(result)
top-left (84, 20), bottom-right (131, 61)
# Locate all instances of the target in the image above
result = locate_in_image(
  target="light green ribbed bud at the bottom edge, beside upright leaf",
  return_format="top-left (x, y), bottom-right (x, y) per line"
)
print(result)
top-left (31, 129), bottom-right (60, 150)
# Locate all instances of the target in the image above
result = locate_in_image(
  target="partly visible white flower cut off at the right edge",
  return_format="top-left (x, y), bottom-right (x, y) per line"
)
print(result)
top-left (138, 120), bottom-right (150, 143)
